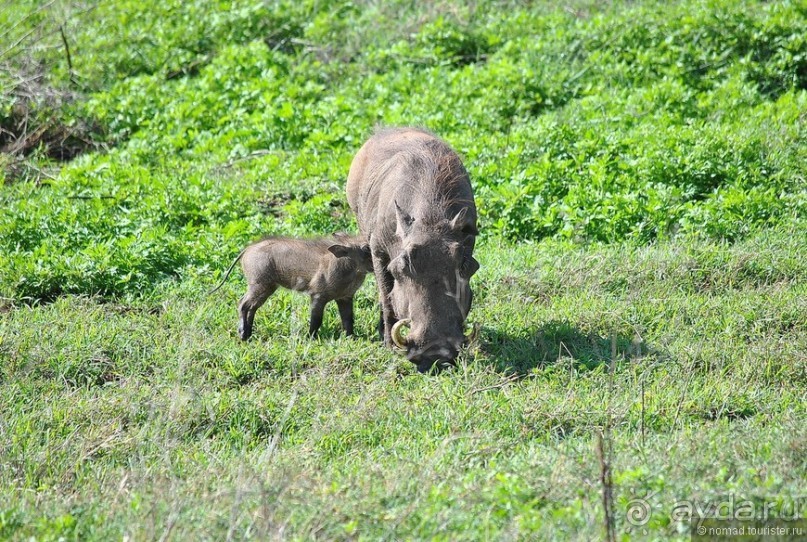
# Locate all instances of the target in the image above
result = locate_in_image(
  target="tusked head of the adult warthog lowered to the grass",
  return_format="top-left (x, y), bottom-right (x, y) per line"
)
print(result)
top-left (388, 205), bottom-right (479, 371)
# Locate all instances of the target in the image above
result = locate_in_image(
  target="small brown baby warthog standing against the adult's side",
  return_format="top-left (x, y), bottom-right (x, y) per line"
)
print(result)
top-left (210, 234), bottom-right (373, 340)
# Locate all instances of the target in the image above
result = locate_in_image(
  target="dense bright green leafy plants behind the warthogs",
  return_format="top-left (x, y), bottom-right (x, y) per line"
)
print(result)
top-left (0, 1), bottom-right (807, 299)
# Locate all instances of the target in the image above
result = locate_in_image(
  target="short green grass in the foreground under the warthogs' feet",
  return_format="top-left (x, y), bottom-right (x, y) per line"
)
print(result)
top-left (0, 223), bottom-right (807, 539)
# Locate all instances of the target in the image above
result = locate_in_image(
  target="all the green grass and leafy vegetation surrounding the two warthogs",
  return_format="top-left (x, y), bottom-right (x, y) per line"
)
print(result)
top-left (0, 0), bottom-right (807, 539)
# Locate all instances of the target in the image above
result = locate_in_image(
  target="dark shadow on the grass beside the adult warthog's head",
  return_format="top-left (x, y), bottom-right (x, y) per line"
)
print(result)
top-left (481, 320), bottom-right (649, 374)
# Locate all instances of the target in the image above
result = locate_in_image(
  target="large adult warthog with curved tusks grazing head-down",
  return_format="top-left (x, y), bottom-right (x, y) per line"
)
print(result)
top-left (347, 128), bottom-right (479, 371)
